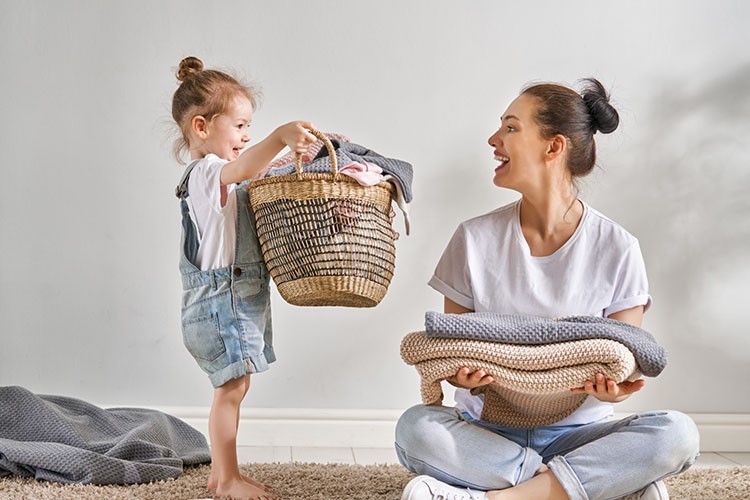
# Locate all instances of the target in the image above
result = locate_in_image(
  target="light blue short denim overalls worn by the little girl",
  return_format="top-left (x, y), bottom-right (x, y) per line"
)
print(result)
top-left (175, 160), bottom-right (276, 387)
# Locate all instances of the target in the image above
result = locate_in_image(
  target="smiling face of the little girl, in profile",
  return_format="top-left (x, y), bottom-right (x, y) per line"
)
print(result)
top-left (199, 96), bottom-right (253, 161)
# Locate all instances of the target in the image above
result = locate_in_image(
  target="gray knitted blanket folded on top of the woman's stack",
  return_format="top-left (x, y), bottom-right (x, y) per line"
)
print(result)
top-left (425, 311), bottom-right (667, 377)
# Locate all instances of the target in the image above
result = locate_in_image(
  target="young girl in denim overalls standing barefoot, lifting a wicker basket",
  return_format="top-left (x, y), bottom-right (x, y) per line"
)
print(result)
top-left (172, 57), bottom-right (316, 499)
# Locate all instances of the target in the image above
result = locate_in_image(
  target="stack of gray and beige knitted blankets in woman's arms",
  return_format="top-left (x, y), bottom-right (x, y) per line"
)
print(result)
top-left (401, 313), bottom-right (666, 428)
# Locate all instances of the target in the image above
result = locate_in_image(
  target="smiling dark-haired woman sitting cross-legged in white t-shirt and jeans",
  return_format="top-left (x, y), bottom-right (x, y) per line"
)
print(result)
top-left (396, 79), bottom-right (699, 500)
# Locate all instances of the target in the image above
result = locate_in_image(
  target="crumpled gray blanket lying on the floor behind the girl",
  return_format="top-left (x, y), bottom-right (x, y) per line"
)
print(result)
top-left (0, 387), bottom-right (211, 485)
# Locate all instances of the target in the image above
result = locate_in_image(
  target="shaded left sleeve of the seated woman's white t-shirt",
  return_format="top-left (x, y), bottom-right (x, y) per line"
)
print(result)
top-left (427, 226), bottom-right (474, 310)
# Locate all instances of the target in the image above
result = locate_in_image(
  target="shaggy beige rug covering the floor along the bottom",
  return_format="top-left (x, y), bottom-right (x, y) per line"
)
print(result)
top-left (0, 463), bottom-right (750, 500)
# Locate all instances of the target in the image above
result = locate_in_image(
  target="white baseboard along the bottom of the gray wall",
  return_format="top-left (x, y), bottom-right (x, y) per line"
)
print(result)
top-left (153, 407), bottom-right (750, 452)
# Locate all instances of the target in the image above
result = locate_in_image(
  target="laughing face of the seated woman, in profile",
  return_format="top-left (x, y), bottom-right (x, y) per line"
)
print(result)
top-left (487, 94), bottom-right (549, 193)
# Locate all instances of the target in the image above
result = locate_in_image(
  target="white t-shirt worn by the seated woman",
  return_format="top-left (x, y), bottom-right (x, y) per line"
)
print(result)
top-left (429, 199), bottom-right (651, 425)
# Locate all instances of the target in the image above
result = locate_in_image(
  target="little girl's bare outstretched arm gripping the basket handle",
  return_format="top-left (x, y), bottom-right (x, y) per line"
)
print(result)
top-left (221, 121), bottom-right (317, 186)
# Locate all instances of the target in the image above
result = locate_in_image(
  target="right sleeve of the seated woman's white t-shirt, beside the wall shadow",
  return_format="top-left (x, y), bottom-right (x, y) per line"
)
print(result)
top-left (604, 241), bottom-right (651, 317)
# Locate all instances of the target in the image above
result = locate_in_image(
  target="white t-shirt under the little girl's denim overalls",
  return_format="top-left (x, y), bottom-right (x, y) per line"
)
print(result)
top-left (187, 154), bottom-right (237, 271)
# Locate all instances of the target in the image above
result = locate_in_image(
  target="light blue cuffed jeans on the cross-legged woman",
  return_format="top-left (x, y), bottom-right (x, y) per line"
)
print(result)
top-left (396, 405), bottom-right (699, 500)
